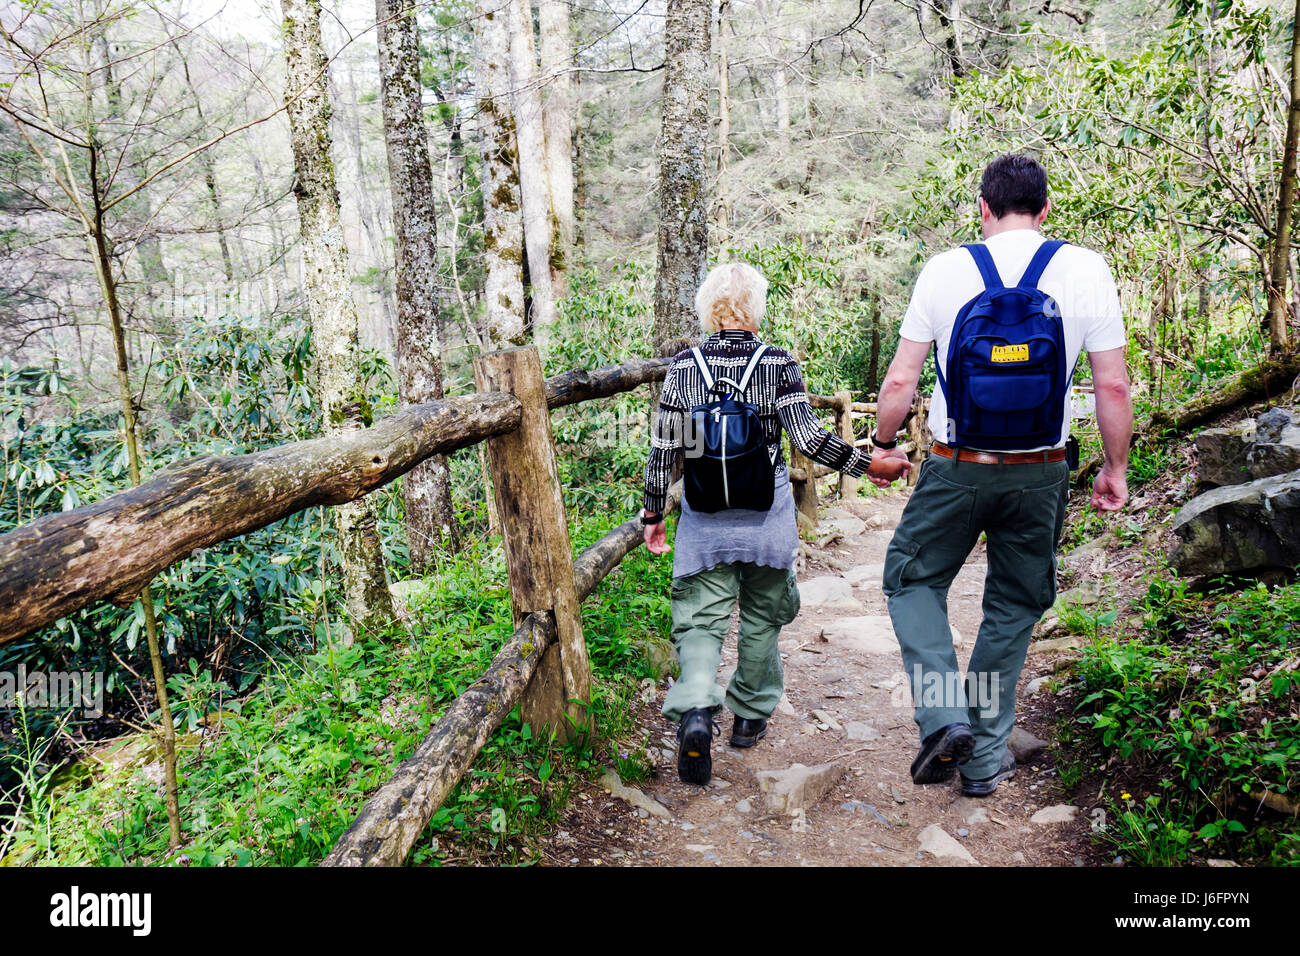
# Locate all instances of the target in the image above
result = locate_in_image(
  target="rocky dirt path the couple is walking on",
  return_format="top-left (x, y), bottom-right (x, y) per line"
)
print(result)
top-left (547, 492), bottom-right (1093, 866)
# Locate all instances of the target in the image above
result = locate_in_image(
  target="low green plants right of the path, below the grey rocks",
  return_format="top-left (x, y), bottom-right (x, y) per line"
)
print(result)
top-left (1062, 568), bottom-right (1300, 865)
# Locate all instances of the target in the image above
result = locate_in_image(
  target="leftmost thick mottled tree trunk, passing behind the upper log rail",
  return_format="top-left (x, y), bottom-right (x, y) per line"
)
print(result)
top-left (282, 0), bottom-right (394, 642)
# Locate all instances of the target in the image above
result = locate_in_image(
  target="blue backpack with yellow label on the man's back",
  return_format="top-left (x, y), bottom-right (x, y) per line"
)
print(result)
top-left (935, 241), bottom-right (1073, 451)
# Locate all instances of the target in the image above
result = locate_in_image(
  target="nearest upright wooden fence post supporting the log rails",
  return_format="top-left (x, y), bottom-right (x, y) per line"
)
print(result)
top-left (475, 346), bottom-right (592, 740)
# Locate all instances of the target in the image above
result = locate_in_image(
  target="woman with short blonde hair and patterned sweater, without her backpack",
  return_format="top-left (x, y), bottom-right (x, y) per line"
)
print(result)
top-left (641, 263), bottom-right (910, 783)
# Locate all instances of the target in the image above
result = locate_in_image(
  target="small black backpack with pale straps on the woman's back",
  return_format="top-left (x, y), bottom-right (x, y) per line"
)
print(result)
top-left (684, 345), bottom-right (776, 514)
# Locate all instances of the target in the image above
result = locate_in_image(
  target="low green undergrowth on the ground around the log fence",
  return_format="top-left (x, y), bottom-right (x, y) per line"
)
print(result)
top-left (0, 516), bottom-right (671, 866)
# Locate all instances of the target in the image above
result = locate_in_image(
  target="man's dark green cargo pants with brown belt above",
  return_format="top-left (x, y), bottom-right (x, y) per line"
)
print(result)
top-left (884, 455), bottom-right (1070, 779)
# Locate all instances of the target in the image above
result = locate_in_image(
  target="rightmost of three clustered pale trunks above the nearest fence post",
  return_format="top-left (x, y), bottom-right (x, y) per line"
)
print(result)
top-left (537, 0), bottom-right (576, 269)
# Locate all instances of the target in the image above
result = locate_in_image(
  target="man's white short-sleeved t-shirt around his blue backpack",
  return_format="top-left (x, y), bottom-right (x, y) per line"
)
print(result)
top-left (900, 229), bottom-right (1127, 451)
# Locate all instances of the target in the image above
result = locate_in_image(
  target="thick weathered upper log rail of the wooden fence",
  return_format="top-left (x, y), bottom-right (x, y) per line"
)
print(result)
top-left (0, 359), bottom-right (671, 644)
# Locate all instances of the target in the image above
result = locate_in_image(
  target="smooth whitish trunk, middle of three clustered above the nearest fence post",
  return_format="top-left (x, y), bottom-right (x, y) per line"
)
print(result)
top-left (508, 0), bottom-right (556, 347)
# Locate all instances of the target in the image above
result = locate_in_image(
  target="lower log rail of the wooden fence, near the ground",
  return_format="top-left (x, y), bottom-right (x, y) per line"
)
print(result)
top-left (321, 485), bottom-right (680, 866)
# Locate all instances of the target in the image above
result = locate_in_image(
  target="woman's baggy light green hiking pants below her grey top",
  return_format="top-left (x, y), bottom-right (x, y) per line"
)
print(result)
top-left (663, 562), bottom-right (800, 721)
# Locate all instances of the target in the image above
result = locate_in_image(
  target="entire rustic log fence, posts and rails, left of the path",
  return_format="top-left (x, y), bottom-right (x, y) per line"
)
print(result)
top-left (0, 349), bottom-right (914, 866)
